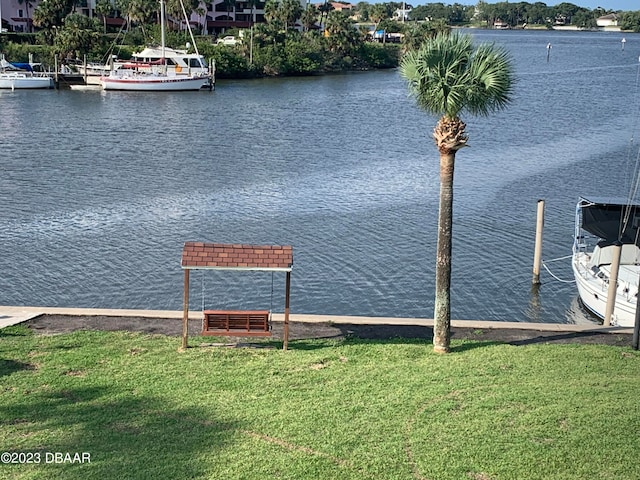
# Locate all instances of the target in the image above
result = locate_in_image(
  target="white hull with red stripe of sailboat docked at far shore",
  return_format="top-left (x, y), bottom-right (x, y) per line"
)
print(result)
top-left (100, 75), bottom-right (208, 92)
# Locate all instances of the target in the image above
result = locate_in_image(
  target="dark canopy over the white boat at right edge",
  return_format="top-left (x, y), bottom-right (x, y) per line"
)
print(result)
top-left (579, 197), bottom-right (640, 245)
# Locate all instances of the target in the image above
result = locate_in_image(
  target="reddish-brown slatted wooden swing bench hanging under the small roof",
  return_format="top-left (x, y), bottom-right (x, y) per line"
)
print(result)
top-left (202, 310), bottom-right (271, 337)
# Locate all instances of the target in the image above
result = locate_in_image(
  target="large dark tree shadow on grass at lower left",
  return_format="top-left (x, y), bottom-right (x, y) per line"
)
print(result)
top-left (0, 387), bottom-right (238, 480)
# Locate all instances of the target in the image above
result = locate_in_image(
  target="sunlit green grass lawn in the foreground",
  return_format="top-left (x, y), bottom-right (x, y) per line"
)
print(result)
top-left (0, 327), bottom-right (640, 480)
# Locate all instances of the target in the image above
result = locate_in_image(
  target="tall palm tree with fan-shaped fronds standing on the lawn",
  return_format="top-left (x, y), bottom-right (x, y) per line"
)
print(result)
top-left (400, 33), bottom-right (513, 353)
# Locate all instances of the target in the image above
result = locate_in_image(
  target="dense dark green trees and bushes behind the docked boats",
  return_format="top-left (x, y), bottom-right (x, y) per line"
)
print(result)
top-left (0, 0), bottom-right (446, 78)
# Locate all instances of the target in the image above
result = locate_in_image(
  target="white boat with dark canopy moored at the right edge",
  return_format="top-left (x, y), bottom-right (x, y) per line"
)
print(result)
top-left (572, 197), bottom-right (640, 327)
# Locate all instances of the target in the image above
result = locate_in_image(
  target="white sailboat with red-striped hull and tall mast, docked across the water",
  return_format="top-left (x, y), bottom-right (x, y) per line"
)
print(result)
top-left (100, 0), bottom-right (211, 92)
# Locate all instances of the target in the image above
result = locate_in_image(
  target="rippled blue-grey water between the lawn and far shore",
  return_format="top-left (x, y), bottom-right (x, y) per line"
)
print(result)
top-left (0, 31), bottom-right (640, 322)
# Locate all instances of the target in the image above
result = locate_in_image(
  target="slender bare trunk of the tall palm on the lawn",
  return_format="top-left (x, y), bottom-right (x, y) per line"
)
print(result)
top-left (433, 151), bottom-right (456, 353)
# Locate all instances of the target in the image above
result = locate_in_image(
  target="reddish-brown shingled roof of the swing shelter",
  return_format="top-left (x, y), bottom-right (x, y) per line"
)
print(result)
top-left (181, 242), bottom-right (293, 272)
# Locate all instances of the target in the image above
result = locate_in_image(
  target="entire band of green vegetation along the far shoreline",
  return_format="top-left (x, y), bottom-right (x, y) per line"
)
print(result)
top-left (0, 0), bottom-right (640, 78)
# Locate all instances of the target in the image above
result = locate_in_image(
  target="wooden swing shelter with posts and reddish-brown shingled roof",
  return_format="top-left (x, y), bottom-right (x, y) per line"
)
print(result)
top-left (181, 242), bottom-right (293, 350)
